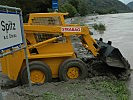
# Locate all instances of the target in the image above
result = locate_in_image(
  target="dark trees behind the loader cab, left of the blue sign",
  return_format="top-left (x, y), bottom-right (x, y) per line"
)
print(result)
top-left (0, 0), bottom-right (52, 22)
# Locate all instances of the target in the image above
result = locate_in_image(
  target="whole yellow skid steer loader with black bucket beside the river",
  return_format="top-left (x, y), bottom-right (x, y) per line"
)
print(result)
top-left (0, 13), bottom-right (130, 84)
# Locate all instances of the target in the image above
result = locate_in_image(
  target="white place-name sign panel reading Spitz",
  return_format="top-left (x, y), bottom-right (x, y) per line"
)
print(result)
top-left (0, 13), bottom-right (23, 50)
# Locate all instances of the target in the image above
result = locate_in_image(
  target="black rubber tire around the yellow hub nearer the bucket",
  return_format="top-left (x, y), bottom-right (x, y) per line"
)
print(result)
top-left (59, 58), bottom-right (88, 81)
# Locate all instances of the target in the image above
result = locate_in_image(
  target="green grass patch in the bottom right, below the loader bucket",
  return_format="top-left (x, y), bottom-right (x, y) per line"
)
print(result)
top-left (95, 81), bottom-right (129, 100)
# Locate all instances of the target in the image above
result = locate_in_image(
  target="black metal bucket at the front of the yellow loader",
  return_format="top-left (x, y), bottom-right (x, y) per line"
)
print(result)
top-left (97, 40), bottom-right (130, 69)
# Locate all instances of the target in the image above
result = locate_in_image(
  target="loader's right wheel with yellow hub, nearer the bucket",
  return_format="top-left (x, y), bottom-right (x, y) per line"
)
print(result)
top-left (59, 59), bottom-right (88, 81)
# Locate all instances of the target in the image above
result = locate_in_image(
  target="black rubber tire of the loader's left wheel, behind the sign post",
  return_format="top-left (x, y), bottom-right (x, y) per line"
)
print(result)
top-left (21, 61), bottom-right (52, 84)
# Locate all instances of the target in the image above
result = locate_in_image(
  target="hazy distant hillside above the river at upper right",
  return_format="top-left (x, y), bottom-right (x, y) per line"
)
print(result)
top-left (89, 0), bottom-right (131, 13)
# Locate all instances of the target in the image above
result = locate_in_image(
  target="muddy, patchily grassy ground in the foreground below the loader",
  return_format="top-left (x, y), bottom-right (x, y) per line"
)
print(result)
top-left (2, 72), bottom-right (132, 100)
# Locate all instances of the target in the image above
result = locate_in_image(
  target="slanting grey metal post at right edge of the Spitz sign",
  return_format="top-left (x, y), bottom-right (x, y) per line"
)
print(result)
top-left (20, 11), bottom-right (32, 92)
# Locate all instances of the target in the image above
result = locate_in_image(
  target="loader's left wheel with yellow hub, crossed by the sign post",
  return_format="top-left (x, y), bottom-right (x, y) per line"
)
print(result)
top-left (21, 61), bottom-right (52, 84)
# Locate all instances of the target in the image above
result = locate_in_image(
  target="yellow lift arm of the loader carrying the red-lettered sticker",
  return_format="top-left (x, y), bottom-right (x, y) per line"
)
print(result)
top-left (24, 25), bottom-right (99, 57)
